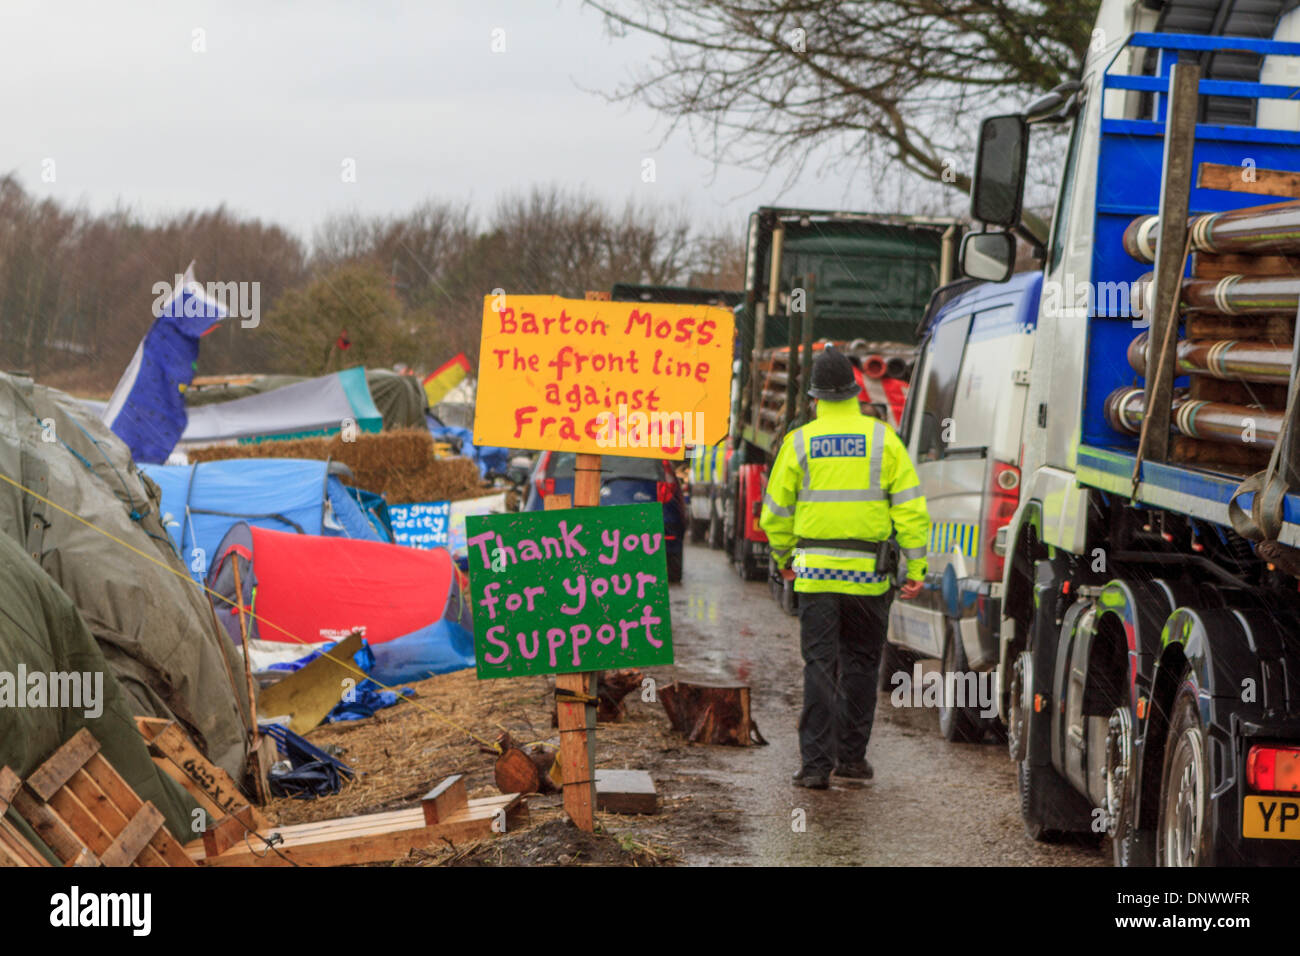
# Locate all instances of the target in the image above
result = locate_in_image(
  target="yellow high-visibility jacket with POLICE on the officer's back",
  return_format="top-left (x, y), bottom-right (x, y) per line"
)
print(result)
top-left (759, 398), bottom-right (930, 594)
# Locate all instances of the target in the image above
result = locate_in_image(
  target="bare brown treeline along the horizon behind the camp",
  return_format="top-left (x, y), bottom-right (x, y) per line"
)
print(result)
top-left (0, 176), bottom-right (744, 393)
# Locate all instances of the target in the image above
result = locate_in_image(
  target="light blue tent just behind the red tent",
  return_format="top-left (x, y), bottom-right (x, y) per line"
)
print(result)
top-left (140, 458), bottom-right (381, 580)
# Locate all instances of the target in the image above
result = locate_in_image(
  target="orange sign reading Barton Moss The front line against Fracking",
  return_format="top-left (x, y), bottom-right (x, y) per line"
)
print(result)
top-left (475, 295), bottom-right (735, 458)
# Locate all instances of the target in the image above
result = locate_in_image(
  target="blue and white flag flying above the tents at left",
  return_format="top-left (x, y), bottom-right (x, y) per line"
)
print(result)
top-left (103, 263), bottom-right (226, 463)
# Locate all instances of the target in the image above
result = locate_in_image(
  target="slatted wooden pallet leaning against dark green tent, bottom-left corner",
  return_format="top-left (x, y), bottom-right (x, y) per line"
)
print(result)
top-left (13, 727), bottom-right (194, 866)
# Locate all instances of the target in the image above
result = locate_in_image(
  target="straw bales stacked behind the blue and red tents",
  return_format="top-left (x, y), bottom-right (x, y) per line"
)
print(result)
top-left (187, 428), bottom-right (485, 505)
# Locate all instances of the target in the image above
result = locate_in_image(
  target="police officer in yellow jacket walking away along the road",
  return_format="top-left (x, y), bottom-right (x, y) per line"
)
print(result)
top-left (759, 346), bottom-right (930, 790)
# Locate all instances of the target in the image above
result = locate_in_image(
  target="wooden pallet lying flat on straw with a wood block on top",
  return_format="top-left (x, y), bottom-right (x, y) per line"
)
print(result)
top-left (185, 774), bottom-right (528, 866)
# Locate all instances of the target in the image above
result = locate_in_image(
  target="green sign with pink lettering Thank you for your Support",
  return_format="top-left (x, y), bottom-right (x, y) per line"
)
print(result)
top-left (465, 502), bottom-right (672, 680)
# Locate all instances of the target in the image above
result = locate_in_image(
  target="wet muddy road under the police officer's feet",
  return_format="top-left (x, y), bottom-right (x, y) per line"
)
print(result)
top-left (659, 548), bottom-right (1109, 866)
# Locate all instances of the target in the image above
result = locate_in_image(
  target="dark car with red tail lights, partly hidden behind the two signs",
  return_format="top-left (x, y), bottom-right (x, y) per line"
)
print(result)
top-left (524, 451), bottom-right (686, 583)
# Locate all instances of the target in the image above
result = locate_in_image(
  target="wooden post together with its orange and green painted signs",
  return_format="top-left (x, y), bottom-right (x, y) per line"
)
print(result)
top-left (467, 286), bottom-right (735, 831)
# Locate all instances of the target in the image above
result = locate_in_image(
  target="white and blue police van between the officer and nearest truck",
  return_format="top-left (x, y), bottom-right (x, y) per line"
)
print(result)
top-left (880, 272), bottom-right (1043, 741)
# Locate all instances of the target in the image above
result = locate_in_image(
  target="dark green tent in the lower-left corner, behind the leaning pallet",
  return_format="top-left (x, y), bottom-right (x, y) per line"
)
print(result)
top-left (0, 535), bottom-right (195, 845)
